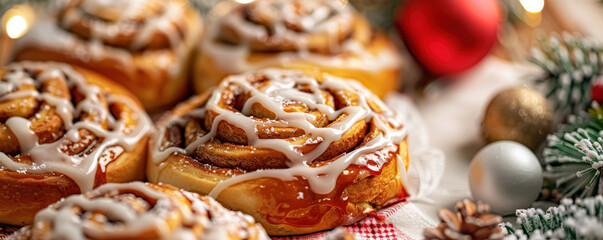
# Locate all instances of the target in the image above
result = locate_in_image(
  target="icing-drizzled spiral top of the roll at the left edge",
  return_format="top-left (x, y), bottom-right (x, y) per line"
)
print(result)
top-left (0, 62), bottom-right (151, 192)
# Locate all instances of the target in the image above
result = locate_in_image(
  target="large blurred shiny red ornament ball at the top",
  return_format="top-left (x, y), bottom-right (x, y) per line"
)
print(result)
top-left (395, 0), bottom-right (501, 76)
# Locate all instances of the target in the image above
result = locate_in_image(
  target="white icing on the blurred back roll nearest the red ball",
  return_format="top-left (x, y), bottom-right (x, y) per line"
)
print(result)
top-left (201, 0), bottom-right (401, 74)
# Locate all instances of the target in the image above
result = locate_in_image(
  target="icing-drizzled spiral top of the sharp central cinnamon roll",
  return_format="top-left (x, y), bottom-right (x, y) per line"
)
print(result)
top-left (153, 69), bottom-right (405, 194)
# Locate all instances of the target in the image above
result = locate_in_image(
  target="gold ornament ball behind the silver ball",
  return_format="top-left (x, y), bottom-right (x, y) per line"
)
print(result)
top-left (482, 86), bottom-right (553, 150)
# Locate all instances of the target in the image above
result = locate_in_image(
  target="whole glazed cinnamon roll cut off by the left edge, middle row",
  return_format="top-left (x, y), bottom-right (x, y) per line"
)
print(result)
top-left (0, 62), bottom-right (153, 225)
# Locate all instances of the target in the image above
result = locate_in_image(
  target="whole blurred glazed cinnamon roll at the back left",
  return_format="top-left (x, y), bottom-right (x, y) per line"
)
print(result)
top-left (14, 0), bottom-right (202, 110)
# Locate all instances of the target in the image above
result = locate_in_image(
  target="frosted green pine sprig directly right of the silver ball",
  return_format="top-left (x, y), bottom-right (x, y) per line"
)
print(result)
top-left (543, 102), bottom-right (603, 200)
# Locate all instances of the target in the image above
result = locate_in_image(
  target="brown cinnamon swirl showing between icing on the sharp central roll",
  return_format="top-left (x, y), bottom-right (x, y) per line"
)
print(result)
top-left (158, 71), bottom-right (397, 170)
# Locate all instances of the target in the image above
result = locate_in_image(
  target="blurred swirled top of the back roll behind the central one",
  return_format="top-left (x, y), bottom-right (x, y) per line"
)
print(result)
top-left (219, 0), bottom-right (360, 53)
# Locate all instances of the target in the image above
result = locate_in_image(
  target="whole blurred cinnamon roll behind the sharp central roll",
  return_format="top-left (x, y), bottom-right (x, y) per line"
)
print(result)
top-left (194, 0), bottom-right (401, 97)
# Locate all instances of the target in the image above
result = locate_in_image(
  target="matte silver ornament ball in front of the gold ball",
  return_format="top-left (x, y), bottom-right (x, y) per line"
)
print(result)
top-left (469, 141), bottom-right (542, 214)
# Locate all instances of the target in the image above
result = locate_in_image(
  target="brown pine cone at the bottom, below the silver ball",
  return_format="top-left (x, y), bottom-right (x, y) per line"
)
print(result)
top-left (423, 199), bottom-right (505, 240)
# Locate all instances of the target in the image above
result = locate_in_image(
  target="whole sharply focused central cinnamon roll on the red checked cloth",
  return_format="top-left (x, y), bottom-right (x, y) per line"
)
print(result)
top-left (147, 69), bottom-right (408, 235)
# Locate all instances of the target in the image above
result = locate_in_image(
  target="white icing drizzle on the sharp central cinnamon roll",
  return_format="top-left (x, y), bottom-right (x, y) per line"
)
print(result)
top-left (151, 69), bottom-right (406, 197)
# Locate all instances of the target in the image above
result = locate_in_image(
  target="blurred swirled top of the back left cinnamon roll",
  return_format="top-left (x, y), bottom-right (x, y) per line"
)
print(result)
top-left (58, 0), bottom-right (190, 50)
